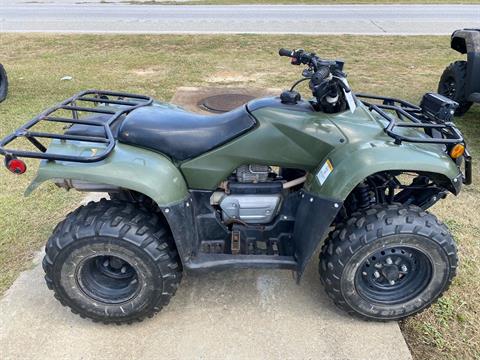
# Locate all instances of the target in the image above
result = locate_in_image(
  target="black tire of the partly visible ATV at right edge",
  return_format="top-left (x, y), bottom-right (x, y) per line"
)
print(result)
top-left (438, 61), bottom-right (472, 116)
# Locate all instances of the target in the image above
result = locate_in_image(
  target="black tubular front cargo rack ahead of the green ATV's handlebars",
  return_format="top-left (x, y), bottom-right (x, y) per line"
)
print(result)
top-left (355, 94), bottom-right (464, 145)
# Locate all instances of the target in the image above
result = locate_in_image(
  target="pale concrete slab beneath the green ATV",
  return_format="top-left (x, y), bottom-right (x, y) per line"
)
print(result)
top-left (0, 246), bottom-right (411, 360)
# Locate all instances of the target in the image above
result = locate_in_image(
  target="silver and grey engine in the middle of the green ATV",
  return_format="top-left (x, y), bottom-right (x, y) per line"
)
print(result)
top-left (211, 165), bottom-right (283, 224)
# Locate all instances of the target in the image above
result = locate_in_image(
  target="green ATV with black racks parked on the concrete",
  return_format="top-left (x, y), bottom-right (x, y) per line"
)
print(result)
top-left (0, 49), bottom-right (472, 323)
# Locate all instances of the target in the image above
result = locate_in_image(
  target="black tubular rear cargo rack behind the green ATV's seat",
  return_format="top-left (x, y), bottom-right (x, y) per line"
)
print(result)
top-left (0, 90), bottom-right (153, 163)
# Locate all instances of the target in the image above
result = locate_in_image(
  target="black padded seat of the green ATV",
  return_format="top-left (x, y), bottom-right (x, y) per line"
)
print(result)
top-left (117, 106), bottom-right (255, 161)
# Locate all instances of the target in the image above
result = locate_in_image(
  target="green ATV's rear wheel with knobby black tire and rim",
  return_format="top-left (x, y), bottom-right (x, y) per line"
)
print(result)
top-left (43, 199), bottom-right (182, 324)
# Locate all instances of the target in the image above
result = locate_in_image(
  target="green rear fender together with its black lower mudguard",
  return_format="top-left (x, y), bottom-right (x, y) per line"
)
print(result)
top-left (25, 140), bottom-right (195, 262)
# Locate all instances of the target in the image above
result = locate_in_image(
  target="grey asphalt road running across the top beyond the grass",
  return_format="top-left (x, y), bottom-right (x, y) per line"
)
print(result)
top-left (0, 0), bottom-right (480, 35)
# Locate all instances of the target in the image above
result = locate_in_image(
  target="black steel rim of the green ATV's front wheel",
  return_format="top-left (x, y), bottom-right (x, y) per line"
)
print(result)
top-left (356, 246), bottom-right (432, 305)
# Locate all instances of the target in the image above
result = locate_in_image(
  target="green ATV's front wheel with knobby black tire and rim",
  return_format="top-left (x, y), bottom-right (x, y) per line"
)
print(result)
top-left (319, 204), bottom-right (458, 321)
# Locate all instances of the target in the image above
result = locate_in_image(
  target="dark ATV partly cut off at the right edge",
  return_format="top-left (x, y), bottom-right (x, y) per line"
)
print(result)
top-left (438, 28), bottom-right (480, 116)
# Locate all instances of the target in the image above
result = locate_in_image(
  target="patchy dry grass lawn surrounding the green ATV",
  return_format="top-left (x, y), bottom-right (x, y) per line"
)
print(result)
top-left (0, 34), bottom-right (480, 359)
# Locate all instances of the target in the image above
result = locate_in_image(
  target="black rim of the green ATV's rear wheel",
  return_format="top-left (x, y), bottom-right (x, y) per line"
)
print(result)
top-left (77, 255), bottom-right (139, 304)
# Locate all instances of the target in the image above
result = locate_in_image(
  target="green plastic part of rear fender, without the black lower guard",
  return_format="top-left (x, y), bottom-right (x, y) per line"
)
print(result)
top-left (25, 140), bottom-right (188, 207)
